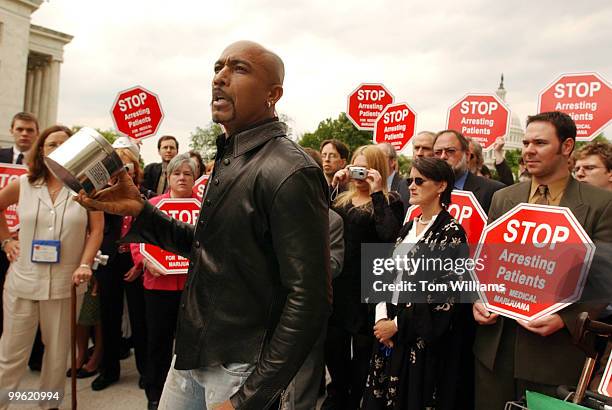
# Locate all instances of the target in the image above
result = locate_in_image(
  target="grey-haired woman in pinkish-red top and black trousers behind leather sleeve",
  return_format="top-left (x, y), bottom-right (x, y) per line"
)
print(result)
top-left (130, 154), bottom-right (196, 409)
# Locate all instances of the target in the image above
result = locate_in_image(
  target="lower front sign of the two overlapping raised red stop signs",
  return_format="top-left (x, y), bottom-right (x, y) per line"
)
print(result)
top-left (373, 103), bottom-right (416, 152)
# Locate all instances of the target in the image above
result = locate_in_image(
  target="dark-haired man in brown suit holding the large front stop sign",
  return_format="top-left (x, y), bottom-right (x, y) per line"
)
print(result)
top-left (473, 112), bottom-right (612, 410)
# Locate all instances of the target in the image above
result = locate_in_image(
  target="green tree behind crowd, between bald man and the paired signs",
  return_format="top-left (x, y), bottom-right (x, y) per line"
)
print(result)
top-left (298, 112), bottom-right (372, 152)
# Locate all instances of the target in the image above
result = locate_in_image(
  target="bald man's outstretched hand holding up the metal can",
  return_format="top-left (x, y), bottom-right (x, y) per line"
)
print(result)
top-left (74, 170), bottom-right (144, 217)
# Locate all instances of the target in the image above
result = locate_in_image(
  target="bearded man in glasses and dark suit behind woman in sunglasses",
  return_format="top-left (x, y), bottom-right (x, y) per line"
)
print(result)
top-left (434, 130), bottom-right (504, 213)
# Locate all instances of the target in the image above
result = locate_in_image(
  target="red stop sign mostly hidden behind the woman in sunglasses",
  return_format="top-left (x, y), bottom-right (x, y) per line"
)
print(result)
top-left (404, 189), bottom-right (487, 252)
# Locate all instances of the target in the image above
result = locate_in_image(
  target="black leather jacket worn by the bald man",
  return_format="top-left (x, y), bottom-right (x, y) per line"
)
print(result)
top-left (125, 120), bottom-right (331, 410)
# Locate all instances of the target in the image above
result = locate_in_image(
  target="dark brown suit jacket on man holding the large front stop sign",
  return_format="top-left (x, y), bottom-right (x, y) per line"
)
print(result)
top-left (474, 177), bottom-right (612, 385)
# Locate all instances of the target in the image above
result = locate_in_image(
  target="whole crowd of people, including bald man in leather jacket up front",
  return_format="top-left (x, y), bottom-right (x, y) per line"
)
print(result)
top-left (0, 42), bottom-right (612, 410)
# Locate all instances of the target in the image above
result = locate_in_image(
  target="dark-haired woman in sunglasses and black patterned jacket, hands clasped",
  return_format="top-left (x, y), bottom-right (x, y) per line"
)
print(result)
top-left (363, 158), bottom-right (468, 410)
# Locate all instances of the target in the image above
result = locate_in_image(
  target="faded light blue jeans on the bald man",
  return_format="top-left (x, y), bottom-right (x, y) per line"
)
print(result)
top-left (159, 356), bottom-right (255, 410)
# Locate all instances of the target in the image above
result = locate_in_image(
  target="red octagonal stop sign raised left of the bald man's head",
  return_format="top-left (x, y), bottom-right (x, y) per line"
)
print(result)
top-left (111, 86), bottom-right (164, 140)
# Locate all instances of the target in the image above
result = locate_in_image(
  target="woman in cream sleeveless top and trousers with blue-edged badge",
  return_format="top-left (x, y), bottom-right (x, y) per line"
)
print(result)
top-left (0, 125), bottom-right (104, 409)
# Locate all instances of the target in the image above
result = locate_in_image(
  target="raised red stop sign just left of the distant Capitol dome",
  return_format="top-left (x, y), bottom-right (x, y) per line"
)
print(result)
top-left (446, 94), bottom-right (510, 151)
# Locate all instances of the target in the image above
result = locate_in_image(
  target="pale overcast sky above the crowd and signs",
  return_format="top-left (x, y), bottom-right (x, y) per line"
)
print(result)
top-left (32, 0), bottom-right (612, 162)
